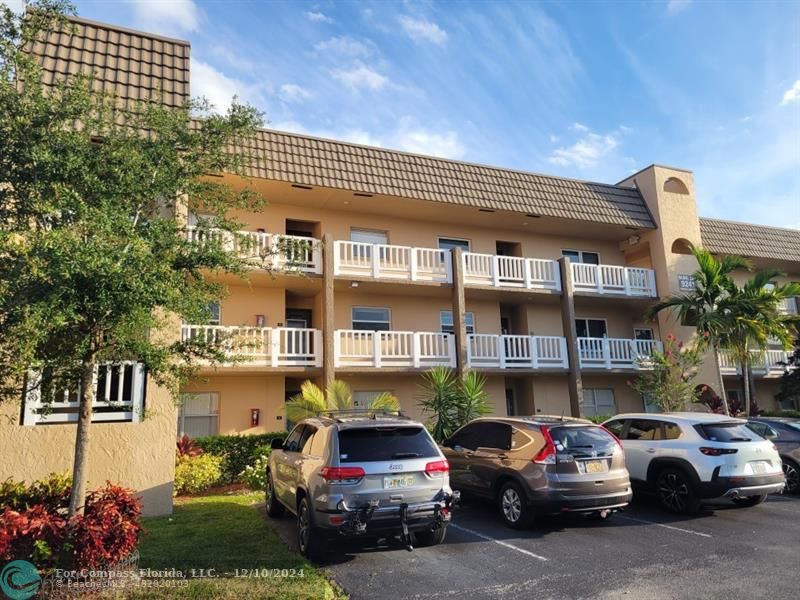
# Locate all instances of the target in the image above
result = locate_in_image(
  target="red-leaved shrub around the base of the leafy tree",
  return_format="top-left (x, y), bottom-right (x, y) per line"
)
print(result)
top-left (0, 476), bottom-right (142, 569)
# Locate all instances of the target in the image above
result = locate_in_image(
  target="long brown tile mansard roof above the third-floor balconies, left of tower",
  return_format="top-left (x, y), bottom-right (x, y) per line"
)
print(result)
top-left (236, 130), bottom-right (655, 228)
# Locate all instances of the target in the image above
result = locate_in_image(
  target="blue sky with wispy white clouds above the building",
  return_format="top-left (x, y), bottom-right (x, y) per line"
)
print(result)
top-left (6, 0), bottom-right (800, 228)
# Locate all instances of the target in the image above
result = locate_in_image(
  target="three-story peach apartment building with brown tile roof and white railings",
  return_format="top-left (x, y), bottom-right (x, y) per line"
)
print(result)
top-left (0, 19), bottom-right (800, 514)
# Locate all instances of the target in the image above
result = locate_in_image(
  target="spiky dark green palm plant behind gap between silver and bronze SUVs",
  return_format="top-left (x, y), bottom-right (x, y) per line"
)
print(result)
top-left (418, 367), bottom-right (491, 442)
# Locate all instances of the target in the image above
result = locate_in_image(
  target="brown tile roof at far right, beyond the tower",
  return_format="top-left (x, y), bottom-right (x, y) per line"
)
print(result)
top-left (700, 217), bottom-right (800, 262)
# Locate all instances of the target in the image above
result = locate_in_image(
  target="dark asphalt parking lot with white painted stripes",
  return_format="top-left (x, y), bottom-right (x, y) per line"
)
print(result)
top-left (270, 495), bottom-right (800, 600)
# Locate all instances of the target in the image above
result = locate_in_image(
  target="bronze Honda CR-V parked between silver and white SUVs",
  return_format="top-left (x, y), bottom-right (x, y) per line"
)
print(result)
top-left (442, 416), bottom-right (633, 528)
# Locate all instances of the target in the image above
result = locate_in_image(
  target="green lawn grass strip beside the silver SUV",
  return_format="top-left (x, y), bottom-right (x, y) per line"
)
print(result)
top-left (125, 494), bottom-right (345, 600)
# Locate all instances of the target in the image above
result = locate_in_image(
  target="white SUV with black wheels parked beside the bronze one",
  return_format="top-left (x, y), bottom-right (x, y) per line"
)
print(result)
top-left (603, 413), bottom-right (784, 513)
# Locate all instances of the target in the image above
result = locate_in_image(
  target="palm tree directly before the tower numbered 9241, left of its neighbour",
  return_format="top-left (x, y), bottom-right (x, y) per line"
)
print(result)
top-left (648, 246), bottom-right (750, 415)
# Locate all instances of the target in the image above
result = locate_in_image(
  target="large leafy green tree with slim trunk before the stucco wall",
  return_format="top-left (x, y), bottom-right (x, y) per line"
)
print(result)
top-left (0, 1), bottom-right (263, 514)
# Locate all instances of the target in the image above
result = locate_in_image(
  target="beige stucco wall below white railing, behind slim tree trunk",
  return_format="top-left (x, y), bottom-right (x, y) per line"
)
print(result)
top-left (0, 381), bottom-right (177, 516)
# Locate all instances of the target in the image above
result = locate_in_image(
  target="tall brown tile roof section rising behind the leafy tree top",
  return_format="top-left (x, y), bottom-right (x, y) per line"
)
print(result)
top-left (29, 17), bottom-right (190, 106)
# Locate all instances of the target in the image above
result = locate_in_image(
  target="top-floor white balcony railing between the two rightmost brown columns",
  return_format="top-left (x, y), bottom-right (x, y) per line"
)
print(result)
top-left (464, 252), bottom-right (561, 291)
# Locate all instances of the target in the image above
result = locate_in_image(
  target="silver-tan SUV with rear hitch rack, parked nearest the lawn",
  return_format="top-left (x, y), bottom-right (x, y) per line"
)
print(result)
top-left (266, 411), bottom-right (457, 557)
